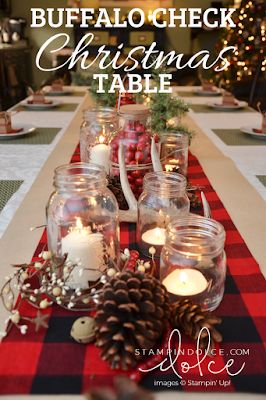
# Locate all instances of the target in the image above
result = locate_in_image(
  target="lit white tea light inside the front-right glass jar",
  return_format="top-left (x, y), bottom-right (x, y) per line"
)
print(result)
top-left (163, 268), bottom-right (208, 296)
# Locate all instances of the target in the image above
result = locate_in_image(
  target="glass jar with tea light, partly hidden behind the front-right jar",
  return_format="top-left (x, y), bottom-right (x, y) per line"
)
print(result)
top-left (137, 172), bottom-right (190, 257)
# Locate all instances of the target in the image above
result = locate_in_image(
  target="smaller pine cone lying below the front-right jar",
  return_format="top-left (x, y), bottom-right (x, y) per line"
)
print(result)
top-left (170, 300), bottom-right (222, 350)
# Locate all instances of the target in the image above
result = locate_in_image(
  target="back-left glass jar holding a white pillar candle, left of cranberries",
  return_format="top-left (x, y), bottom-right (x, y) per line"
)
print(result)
top-left (80, 107), bottom-right (118, 174)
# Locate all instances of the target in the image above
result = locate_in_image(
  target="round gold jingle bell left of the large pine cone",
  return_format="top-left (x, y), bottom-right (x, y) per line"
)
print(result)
top-left (70, 317), bottom-right (96, 344)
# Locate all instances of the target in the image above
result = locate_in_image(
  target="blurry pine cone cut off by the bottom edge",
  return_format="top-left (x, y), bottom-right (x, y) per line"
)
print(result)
top-left (87, 376), bottom-right (154, 400)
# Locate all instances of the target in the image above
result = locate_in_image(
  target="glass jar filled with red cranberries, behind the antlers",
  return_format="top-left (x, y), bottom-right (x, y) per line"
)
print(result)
top-left (111, 104), bottom-right (152, 198)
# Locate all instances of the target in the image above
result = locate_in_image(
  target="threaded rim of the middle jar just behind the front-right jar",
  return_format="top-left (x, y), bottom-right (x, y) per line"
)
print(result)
top-left (143, 171), bottom-right (187, 196)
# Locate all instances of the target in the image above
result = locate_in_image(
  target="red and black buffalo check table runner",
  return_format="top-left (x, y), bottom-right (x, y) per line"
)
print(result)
top-left (0, 148), bottom-right (266, 394)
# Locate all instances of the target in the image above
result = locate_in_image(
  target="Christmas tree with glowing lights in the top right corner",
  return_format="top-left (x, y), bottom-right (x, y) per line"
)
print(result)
top-left (217, 0), bottom-right (266, 87)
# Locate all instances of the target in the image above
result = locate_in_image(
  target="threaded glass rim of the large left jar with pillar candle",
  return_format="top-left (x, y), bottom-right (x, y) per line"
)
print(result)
top-left (54, 162), bottom-right (107, 191)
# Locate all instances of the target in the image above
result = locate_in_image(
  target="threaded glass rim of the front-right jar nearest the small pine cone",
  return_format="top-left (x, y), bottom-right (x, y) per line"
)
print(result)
top-left (166, 214), bottom-right (226, 257)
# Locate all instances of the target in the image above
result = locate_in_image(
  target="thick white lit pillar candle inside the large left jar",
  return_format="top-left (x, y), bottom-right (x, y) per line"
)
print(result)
top-left (61, 218), bottom-right (104, 289)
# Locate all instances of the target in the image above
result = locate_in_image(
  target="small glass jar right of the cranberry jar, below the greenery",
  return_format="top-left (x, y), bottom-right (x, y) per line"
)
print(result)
top-left (160, 132), bottom-right (189, 176)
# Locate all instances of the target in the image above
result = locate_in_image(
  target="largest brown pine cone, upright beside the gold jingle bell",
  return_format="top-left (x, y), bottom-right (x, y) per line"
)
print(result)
top-left (96, 271), bottom-right (170, 370)
